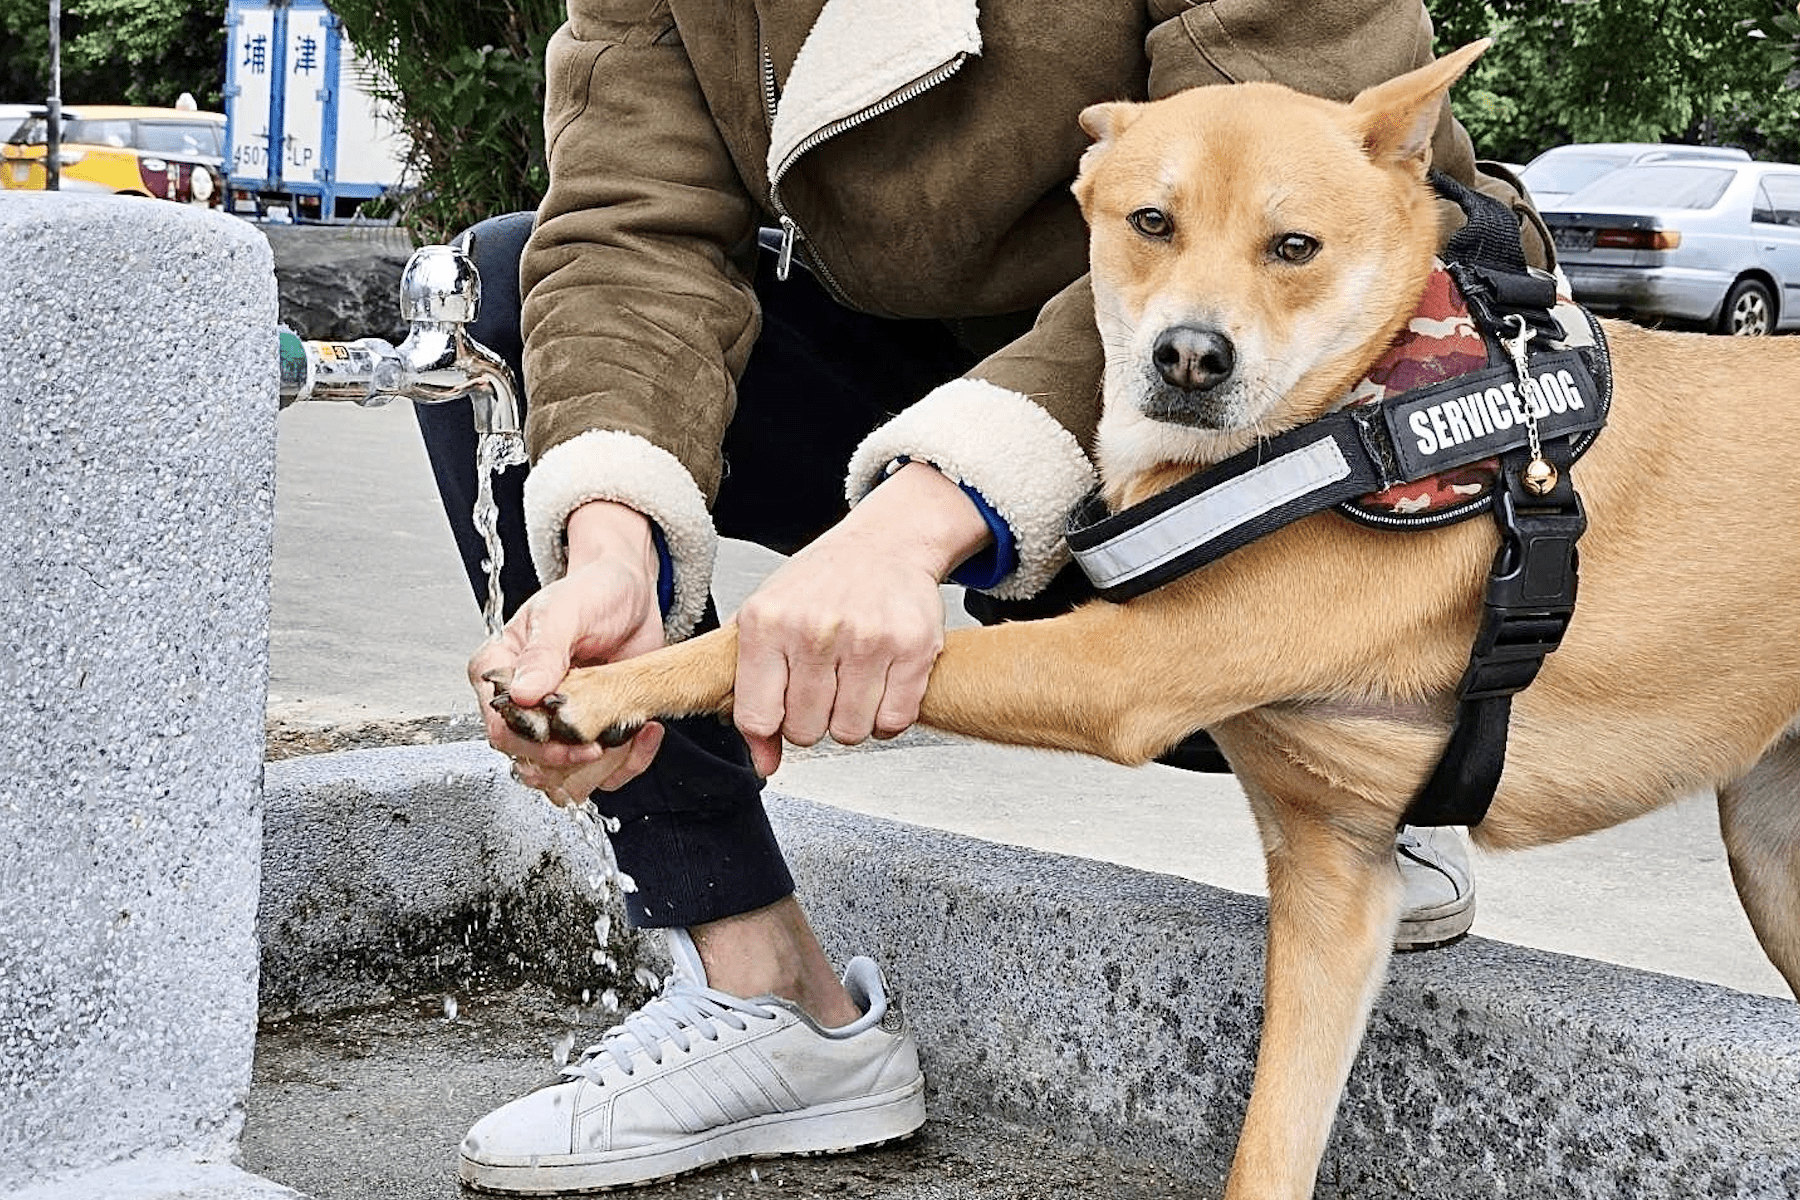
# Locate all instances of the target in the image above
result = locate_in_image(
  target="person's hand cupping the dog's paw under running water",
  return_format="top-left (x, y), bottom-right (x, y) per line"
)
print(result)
top-left (468, 502), bottom-right (662, 806)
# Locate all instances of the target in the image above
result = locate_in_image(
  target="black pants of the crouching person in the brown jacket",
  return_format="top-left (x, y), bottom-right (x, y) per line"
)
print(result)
top-left (414, 212), bottom-right (1222, 927)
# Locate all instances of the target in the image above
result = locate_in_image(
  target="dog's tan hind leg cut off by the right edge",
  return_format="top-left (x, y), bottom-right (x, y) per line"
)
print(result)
top-left (1719, 736), bottom-right (1800, 997)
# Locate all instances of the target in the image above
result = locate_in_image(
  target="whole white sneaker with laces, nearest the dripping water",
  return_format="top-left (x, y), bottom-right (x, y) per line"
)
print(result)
top-left (461, 930), bottom-right (925, 1195)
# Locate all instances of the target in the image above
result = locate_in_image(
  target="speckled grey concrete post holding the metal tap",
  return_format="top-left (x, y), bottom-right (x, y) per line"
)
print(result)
top-left (0, 193), bottom-right (293, 1200)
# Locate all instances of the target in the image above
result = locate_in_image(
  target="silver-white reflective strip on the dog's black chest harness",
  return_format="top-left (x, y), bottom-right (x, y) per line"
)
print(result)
top-left (1075, 437), bottom-right (1350, 588)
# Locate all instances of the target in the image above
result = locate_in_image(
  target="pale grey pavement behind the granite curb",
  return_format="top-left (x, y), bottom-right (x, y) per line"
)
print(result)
top-left (270, 403), bottom-right (1789, 997)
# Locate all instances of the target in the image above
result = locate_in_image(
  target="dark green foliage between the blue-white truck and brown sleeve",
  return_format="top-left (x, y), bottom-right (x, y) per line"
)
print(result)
top-left (331, 0), bottom-right (563, 241)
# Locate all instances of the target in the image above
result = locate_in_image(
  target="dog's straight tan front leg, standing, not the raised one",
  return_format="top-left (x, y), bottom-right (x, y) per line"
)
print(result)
top-left (1226, 766), bottom-right (1400, 1200)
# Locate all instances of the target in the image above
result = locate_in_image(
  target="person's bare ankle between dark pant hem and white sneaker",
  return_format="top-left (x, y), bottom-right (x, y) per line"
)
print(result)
top-left (688, 896), bottom-right (862, 1029)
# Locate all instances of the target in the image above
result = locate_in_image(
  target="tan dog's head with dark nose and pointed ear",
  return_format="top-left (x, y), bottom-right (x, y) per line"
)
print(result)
top-left (1075, 41), bottom-right (1489, 495)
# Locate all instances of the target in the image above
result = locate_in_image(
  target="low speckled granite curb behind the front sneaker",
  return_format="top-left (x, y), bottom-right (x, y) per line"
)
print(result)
top-left (263, 745), bottom-right (1800, 1200)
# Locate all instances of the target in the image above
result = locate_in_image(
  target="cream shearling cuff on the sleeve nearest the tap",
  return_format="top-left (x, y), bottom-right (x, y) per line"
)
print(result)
top-left (526, 430), bottom-right (718, 642)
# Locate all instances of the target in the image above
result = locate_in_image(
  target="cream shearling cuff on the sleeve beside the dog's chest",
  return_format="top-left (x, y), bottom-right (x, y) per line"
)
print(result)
top-left (844, 380), bottom-right (1094, 599)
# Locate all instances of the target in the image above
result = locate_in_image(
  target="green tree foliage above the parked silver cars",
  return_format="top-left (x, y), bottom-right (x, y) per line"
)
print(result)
top-left (1427, 0), bottom-right (1800, 162)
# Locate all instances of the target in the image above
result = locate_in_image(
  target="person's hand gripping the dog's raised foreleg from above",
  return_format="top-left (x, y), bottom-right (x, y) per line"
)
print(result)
top-left (733, 462), bottom-right (992, 777)
